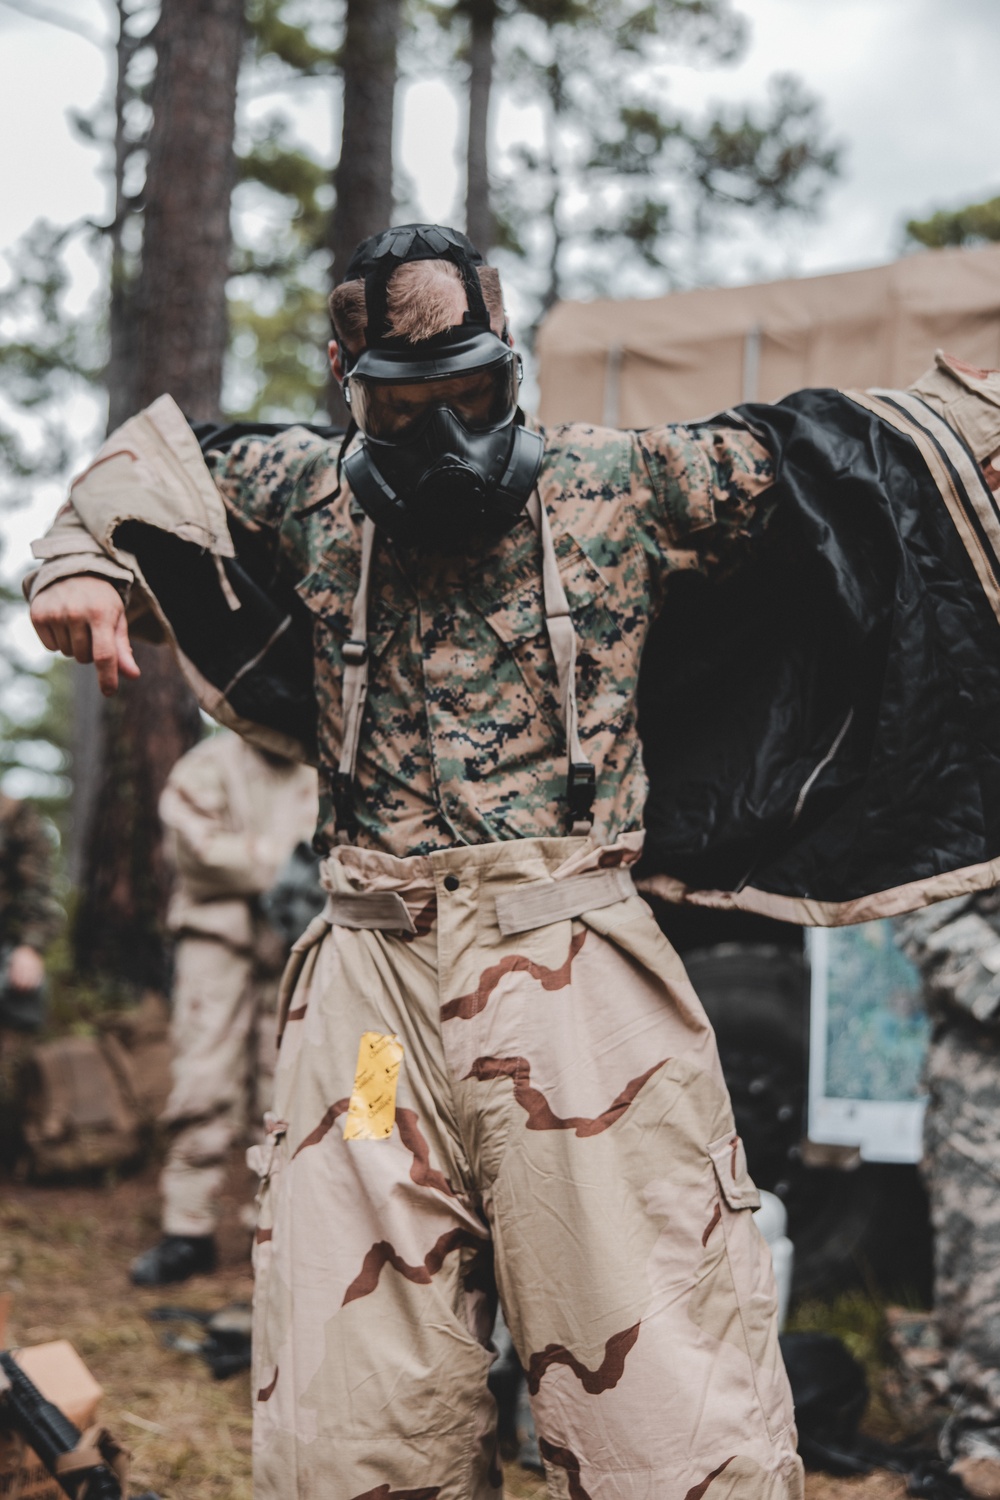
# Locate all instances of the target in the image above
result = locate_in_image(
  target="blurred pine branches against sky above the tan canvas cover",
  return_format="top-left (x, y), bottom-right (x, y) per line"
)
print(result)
top-left (501, 0), bottom-right (837, 322)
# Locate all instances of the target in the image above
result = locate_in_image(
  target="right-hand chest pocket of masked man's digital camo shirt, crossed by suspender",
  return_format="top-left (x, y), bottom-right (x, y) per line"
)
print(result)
top-left (484, 536), bottom-right (636, 726)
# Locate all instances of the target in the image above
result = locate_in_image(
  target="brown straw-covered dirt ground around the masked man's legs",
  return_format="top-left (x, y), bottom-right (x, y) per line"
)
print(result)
top-left (0, 1161), bottom-right (904, 1500)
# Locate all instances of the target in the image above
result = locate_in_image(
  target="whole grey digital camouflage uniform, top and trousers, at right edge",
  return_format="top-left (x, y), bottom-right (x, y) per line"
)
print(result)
top-left (898, 891), bottom-right (1000, 1460)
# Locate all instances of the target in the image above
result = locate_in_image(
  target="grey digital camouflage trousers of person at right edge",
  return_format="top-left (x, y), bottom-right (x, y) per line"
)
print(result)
top-left (924, 1007), bottom-right (1000, 1460)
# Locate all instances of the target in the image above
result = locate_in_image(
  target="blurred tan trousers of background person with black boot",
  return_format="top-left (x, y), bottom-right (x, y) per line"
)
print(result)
top-left (160, 935), bottom-right (277, 1235)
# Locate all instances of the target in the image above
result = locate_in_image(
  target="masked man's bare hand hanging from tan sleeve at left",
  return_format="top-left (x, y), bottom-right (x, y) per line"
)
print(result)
top-left (31, 573), bottom-right (139, 698)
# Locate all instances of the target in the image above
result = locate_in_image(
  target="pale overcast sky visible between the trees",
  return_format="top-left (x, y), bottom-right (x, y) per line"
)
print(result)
top-left (0, 0), bottom-right (1000, 615)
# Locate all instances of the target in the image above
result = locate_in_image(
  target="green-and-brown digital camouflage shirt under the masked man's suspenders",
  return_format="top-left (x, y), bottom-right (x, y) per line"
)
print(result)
top-left (208, 425), bottom-right (774, 855)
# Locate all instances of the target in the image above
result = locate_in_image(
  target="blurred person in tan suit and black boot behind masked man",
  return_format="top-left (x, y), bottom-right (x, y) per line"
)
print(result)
top-left (132, 732), bottom-right (316, 1286)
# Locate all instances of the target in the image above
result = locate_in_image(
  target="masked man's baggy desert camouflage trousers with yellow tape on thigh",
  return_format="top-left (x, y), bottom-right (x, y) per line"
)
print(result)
top-left (250, 839), bottom-right (801, 1500)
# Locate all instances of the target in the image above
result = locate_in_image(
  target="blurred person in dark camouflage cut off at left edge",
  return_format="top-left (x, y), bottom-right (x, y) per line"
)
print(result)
top-left (0, 794), bottom-right (58, 1032)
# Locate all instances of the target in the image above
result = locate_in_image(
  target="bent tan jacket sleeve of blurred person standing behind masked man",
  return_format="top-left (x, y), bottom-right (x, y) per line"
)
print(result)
top-left (159, 752), bottom-right (282, 902)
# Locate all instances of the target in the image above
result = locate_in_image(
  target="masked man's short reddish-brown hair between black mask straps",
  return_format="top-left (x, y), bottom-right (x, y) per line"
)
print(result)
top-left (330, 261), bottom-right (505, 350)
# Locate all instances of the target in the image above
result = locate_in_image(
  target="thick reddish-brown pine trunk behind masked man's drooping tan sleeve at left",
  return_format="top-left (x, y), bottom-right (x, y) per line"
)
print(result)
top-left (73, 0), bottom-right (243, 987)
